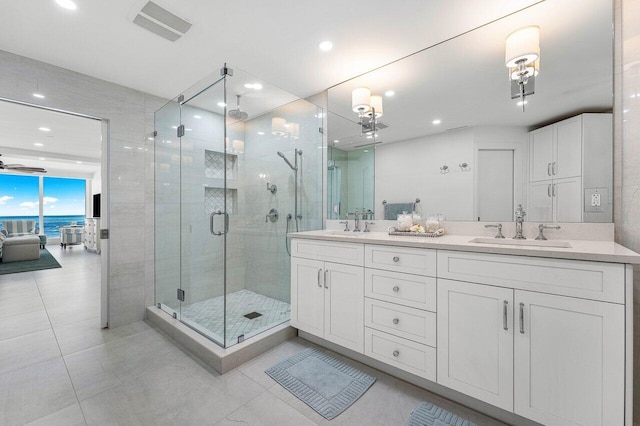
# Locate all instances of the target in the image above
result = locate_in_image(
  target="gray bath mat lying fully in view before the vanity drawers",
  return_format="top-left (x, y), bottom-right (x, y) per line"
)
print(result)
top-left (265, 348), bottom-right (376, 420)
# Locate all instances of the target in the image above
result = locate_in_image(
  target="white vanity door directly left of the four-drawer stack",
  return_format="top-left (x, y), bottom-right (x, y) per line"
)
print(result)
top-left (324, 262), bottom-right (364, 353)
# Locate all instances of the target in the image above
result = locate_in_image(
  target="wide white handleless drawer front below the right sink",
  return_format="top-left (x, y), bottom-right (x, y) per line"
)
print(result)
top-left (438, 250), bottom-right (625, 303)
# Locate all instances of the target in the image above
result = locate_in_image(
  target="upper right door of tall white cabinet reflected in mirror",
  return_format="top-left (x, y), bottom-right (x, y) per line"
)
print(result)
top-left (551, 116), bottom-right (582, 179)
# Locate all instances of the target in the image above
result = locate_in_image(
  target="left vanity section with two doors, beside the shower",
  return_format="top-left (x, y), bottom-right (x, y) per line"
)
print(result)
top-left (291, 240), bottom-right (364, 353)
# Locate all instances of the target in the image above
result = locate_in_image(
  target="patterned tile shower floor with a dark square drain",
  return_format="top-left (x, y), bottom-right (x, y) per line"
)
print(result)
top-left (181, 290), bottom-right (291, 347)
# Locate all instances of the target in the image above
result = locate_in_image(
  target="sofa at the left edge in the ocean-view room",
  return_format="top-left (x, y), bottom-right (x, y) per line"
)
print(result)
top-left (0, 220), bottom-right (40, 263)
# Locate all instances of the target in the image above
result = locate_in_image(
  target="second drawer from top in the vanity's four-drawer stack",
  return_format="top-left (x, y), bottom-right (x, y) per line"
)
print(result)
top-left (364, 268), bottom-right (436, 312)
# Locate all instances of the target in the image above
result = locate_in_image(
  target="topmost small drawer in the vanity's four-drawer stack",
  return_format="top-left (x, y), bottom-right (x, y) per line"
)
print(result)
top-left (364, 244), bottom-right (436, 277)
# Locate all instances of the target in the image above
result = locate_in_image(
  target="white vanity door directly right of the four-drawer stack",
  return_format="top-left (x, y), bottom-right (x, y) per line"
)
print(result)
top-left (437, 279), bottom-right (513, 411)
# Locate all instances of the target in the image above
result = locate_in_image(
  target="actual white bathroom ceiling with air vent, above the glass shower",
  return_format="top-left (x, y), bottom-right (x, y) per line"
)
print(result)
top-left (0, 0), bottom-right (537, 98)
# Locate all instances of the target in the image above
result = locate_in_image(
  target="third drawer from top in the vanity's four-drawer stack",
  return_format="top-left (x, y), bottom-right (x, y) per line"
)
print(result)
top-left (364, 298), bottom-right (436, 346)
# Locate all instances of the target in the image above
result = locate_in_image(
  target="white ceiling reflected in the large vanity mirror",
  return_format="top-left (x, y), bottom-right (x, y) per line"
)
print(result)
top-left (329, 0), bottom-right (613, 149)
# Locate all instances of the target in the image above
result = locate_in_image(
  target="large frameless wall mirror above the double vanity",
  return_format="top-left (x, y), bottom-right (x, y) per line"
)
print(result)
top-left (328, 0), bottom-right (613, 222)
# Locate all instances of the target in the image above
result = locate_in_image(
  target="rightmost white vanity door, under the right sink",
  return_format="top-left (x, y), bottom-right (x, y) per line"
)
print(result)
top-left (514, 290), bottom-right (625, 426)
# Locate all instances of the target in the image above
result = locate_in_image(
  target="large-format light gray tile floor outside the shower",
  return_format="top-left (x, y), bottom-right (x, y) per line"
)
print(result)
top-left (0, 247), bottom-right (510, 426)
